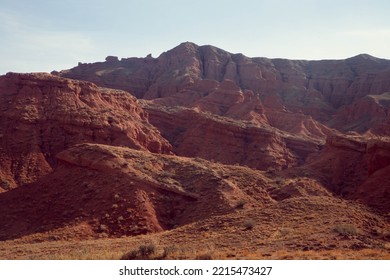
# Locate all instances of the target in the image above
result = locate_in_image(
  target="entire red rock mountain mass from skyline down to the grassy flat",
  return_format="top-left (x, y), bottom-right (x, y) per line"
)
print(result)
top-left (0, 42), bottom-right (390, 256)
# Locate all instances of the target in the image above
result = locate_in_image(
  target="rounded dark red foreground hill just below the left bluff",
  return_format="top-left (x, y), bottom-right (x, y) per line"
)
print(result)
top-left (0, 144), bottom-right (273, 240)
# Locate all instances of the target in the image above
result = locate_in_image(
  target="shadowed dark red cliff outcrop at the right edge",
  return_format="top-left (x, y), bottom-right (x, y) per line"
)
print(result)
top-left (303, 134), bottom-right (390, 213)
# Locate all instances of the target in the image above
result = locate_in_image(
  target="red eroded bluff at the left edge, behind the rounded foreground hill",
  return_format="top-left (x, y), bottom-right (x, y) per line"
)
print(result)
top-left (0, 73), bottom-right (171, 190)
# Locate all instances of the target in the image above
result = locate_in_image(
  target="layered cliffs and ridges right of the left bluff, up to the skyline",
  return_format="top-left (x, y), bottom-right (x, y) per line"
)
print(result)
top-left (51, 42), bottom-right (390, 215)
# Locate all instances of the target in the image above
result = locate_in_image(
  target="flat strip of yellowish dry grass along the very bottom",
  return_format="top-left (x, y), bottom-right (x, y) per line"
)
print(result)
top-left (0, 234), bottom-right (390, 260)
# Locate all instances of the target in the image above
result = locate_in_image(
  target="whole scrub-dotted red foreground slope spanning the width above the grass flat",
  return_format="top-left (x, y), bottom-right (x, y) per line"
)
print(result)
top-left (0, 144), bottom-right (390, 251)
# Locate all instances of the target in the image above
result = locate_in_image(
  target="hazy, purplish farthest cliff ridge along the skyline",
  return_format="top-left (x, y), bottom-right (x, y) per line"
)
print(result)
top-left (56, 42), bottom-right (390, 135)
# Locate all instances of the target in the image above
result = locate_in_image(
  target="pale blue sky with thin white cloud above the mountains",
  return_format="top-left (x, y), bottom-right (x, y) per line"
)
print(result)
top-left (0, 0), bottom-right (390, 74)
